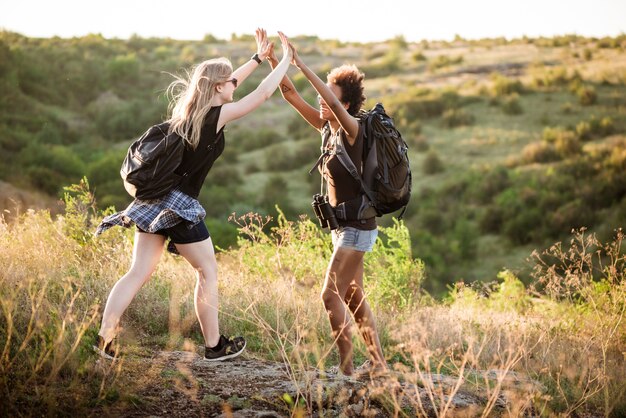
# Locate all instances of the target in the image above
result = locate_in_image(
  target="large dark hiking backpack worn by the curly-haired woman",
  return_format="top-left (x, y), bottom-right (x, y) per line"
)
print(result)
top-left (311, 103), bottom-right (412, 220)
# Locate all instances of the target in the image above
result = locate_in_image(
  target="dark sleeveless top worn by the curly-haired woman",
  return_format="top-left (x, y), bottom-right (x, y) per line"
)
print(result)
top-left (322, 123), bottom-right (376, 231)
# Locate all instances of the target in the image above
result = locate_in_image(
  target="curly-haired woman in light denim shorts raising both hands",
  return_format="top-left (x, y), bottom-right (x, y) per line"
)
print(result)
top-left (268, 44), bottom-right (387, 376)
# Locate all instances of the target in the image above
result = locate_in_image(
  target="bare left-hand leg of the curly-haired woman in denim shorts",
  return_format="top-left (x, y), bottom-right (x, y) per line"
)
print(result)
top-left (321, 248), bottom-right (364, 376)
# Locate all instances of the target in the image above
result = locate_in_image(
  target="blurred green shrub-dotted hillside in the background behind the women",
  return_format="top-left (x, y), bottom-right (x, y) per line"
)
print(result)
top-left (0, 32), bottom-right (626, 295)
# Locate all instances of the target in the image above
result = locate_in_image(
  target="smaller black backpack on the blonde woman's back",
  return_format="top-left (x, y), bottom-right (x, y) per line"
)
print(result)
top-left (120, 122), bottom-right (185, 200)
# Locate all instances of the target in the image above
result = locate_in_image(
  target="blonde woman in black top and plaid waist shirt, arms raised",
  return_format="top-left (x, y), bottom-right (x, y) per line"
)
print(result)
top-left (94, 29), bottom-right (292, 361)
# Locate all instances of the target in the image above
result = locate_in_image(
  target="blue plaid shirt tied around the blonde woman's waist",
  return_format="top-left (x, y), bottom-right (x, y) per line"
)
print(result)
top-left (96, 189), bottom-right (206, 235)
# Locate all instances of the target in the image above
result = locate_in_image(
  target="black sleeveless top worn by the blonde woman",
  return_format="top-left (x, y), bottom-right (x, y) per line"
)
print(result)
top-left (175, 106), bottom-right (224, 199)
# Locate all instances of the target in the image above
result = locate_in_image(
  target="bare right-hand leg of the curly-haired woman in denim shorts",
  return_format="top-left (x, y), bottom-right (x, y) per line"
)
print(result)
top-left (345, 260), bottom-right (387, 369)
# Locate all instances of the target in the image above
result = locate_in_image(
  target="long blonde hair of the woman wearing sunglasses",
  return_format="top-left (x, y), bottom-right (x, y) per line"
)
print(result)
top-left (167, 58), bottom-right (233, 149)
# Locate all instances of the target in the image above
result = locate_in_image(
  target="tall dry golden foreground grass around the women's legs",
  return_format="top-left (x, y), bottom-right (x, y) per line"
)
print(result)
top-left (0, 188), bottom-right (626, 417)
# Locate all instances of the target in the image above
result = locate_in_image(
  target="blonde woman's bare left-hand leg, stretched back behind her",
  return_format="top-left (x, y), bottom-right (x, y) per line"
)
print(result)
top-left (98, 232), bottom-right (165, 343)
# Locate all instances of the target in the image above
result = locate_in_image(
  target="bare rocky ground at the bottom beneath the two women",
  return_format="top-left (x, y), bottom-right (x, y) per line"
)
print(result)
top-left (91, 351), bottom-right (540, 418)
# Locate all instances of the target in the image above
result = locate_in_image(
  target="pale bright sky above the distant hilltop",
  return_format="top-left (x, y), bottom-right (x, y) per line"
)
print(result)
top-left (0, 0), bottom-right (626, 43)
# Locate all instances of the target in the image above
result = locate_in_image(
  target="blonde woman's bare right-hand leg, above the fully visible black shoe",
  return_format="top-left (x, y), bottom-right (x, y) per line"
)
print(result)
top-left (176, 238), bottom-right (220, 347)
